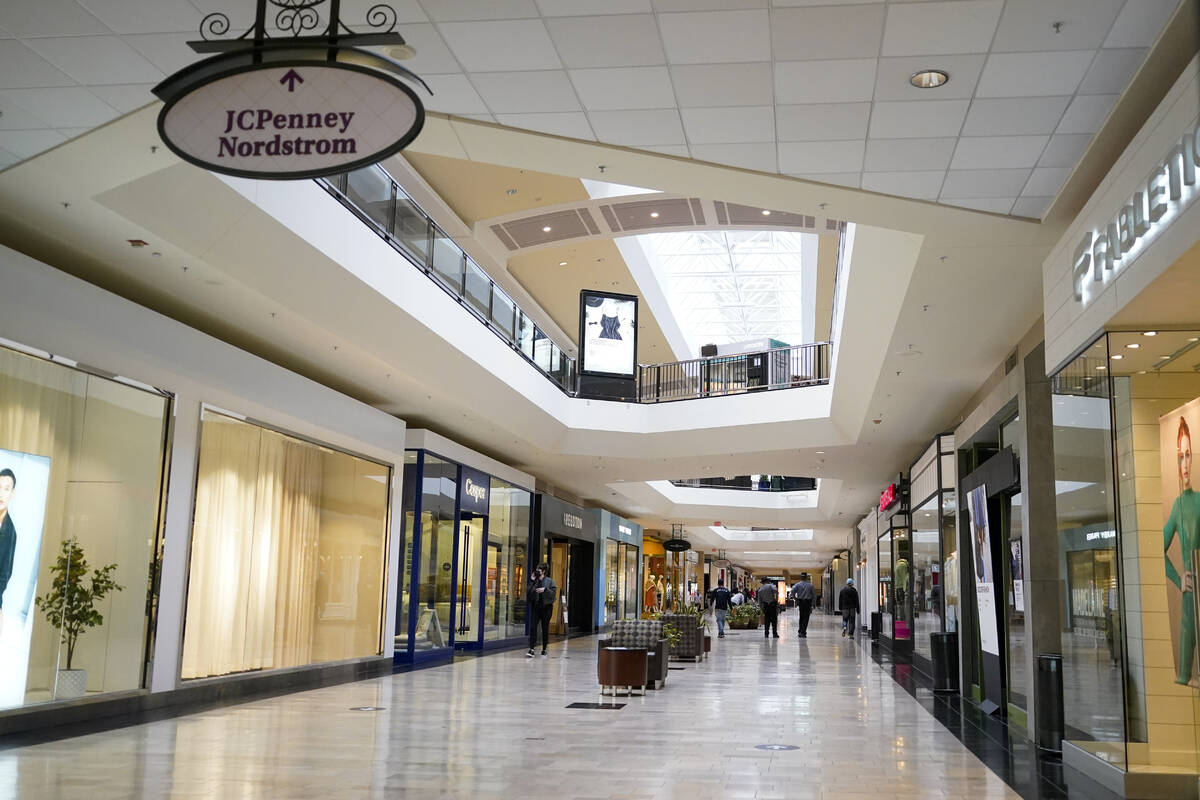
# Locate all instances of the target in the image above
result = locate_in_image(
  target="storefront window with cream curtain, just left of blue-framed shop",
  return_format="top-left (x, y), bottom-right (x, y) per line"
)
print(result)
top-left (182, 410), bottom-right (391, 679)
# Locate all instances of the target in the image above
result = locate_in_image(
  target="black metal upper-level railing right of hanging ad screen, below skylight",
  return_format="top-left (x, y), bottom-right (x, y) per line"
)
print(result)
top-left (637, 342), bottom-right (829, 403)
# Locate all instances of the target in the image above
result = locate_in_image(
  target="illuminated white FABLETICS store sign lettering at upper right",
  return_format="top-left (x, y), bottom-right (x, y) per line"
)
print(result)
top-left (1072, 117), bottom-right (1200, 306)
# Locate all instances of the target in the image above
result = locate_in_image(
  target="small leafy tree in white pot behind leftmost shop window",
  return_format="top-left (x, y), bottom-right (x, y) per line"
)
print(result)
top-left (36, 537), bottom-right (124, 699)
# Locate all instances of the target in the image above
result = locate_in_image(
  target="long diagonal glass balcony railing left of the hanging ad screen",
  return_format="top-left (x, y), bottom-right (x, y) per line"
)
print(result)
top-left (317, 164), bottom-right (575, 395)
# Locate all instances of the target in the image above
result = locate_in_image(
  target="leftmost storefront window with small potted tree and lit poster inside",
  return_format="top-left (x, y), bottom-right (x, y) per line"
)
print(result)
top-left (0, 348), bottom-right (170, 708)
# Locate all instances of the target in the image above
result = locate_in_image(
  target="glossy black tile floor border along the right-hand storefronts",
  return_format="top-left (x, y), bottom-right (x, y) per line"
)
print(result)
top-left (864, 643), bottom-right (1068, 800)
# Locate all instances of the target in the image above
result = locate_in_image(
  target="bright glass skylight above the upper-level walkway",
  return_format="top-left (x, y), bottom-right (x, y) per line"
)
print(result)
top-left (646, 230), bottom-right (811, 351)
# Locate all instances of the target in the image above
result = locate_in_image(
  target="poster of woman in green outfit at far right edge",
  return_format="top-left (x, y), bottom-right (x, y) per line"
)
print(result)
top-left (1158, 398), bottom-right (1200, 686)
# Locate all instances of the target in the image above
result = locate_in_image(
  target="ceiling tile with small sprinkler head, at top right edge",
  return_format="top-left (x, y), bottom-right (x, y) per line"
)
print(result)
top-left (991, 0), bottom-right (1124, 53)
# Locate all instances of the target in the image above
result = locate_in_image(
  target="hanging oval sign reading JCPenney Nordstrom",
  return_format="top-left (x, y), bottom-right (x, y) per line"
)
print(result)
top-left (158, 61), bottom-right (425, 180)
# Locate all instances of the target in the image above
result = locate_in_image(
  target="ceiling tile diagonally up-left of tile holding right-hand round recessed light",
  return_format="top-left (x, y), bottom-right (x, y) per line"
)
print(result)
top-left (770, 5), bottom-right (884, 61)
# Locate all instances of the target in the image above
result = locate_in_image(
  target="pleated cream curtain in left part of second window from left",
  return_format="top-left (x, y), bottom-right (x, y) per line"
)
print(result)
top-left (182, 414), bottom-right (322, 678)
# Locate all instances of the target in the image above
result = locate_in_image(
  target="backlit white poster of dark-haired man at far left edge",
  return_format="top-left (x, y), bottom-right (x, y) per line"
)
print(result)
top-left (0, 450), bottom-right (50, 708)
